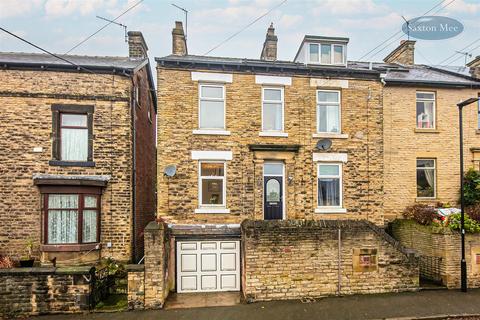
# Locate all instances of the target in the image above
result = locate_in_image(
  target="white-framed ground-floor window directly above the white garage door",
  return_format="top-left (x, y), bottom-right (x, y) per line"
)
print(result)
top-left (199, 161), bottom-right (226, 207)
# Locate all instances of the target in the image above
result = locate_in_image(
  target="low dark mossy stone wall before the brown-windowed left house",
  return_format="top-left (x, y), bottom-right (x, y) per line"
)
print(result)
top-left (0, 267), bottom-right (95, 319)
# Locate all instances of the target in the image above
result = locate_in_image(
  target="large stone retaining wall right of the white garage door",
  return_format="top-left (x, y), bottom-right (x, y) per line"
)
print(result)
top-left (241, 220), bottom-right (419, 302)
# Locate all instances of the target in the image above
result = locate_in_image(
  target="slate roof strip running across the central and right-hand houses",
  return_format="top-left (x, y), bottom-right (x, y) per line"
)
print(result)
top-left (155, 55), bottom-right (480, 87)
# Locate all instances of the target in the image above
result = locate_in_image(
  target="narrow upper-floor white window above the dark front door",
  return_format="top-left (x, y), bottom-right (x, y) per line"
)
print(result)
top-left (262, 88), bottom-right (284, 132)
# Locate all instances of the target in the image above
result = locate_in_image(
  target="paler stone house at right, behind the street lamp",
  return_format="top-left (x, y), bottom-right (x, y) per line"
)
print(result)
top-left (382, 40), bottom-right (480, 221)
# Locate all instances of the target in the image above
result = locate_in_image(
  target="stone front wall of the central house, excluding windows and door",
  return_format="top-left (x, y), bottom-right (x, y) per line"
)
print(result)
top-left (157, 66), bottom-right (383, 225)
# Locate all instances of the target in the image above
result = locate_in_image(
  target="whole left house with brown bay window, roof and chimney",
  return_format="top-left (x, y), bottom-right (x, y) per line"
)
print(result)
top-left (0, 32), bottom-right (157, 265)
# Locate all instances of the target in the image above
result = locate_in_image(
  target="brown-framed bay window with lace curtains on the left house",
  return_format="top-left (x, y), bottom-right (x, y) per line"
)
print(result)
top-left (44, 193), bottom-right (100, 244)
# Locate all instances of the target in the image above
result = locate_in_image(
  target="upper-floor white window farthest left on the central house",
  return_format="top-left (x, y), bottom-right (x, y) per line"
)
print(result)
top-left (199, 84), bottom-right (225, 130)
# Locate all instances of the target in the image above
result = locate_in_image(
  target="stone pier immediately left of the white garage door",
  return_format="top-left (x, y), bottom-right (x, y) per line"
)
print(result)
top-left (127, 221), bottom-right (173, 310)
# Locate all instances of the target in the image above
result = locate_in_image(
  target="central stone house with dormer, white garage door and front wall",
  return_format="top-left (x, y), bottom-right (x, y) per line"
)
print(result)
top-left (152, 22), bottom-right (418, 307)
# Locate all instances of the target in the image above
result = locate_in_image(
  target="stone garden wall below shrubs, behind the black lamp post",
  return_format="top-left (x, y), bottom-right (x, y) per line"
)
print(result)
top-left (391, 219), bottom-right (480, 289)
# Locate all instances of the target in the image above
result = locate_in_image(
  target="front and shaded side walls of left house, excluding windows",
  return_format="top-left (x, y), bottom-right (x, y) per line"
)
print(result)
top-left (0, 52), bottom-right (156, 265)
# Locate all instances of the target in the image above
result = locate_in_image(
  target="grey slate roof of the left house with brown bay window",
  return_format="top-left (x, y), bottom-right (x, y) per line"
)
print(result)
top-left (0, 52), bottom-right (148, 72)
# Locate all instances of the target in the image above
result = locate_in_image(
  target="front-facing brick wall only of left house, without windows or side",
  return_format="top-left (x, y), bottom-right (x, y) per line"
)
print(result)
top-left (0, 70), bottom-right (132, 260)
